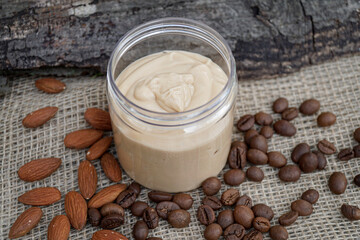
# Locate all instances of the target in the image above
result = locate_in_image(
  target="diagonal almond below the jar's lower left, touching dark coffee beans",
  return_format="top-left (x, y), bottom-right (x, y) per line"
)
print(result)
top-left (88, 184), bottom-right (126, 208)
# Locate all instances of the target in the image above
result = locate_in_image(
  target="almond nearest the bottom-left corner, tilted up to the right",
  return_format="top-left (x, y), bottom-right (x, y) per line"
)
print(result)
top-left (9, 207), bottom-right (43, 239)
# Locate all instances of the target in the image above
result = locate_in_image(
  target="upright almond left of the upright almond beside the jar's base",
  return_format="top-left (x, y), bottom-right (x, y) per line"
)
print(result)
top-left (78, 160), bottom-right (97, 199)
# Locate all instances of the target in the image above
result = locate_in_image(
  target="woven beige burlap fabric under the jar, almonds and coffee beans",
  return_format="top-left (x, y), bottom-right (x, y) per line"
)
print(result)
top-left (0, 56), bottom-right (360, 239)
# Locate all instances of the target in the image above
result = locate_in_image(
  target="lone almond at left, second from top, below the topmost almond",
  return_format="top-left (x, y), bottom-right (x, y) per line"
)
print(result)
top-left (23, 107), bottom-right (58, 128)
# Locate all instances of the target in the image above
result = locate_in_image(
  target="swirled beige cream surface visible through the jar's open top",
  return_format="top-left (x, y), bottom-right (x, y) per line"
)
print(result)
top-left (116, 51), bottom-right (227, 112)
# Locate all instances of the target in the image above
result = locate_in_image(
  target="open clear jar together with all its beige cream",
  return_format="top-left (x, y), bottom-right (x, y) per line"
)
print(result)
top-left (107, 18), bottom-right (237, 192)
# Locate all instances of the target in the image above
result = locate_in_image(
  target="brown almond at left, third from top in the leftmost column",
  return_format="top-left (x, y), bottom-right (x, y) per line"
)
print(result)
top-left (18, 158), bottom-right (61, 182)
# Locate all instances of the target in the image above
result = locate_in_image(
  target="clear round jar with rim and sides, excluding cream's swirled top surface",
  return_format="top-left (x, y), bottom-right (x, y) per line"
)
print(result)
top-left (107, 18), bottom-right (237, 192)
